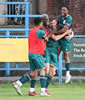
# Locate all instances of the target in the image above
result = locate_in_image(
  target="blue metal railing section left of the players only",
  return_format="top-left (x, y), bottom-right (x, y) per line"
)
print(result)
top-left (0, 2), bottom-right (41, 76)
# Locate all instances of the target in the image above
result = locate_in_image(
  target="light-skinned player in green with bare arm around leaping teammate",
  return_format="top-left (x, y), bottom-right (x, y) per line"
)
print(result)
top-left (45, 16), bottom-right (71, 89)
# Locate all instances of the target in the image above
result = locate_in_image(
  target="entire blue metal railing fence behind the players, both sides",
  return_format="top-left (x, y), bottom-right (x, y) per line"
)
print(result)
top-left (0, 2), bottom-right (85, 84)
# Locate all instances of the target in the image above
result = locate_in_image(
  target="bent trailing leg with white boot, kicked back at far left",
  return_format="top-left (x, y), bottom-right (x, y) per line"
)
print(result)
top-left (13, 55), bottom-right (36, 95)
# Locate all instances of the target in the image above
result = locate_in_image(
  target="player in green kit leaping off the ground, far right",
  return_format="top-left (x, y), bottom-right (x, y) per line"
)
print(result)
top-left (57, 7), bottom-right (74, 84)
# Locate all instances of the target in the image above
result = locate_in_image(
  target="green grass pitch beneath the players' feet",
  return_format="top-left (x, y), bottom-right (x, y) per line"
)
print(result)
top-left (0, 83), bottom-right (85, 100)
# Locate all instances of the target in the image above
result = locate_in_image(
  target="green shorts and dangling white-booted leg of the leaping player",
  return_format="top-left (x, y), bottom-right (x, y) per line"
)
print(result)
top-left (60, 39), bottom-right (72, 84)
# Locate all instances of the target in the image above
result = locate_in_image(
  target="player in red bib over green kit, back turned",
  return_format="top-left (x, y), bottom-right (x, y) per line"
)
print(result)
top-left (13, 18), bottom-right (48, 96)
